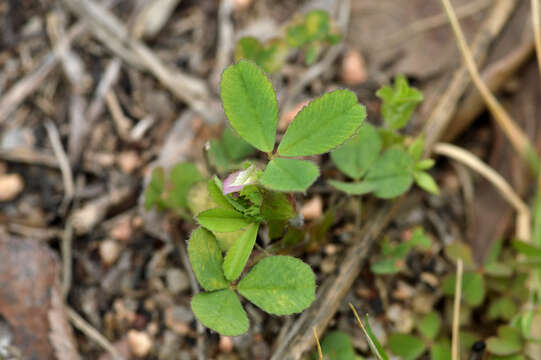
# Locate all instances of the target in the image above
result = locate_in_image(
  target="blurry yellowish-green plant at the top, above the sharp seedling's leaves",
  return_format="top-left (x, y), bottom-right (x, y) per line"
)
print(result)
top-left (235, 10), bottom-right (340, 73)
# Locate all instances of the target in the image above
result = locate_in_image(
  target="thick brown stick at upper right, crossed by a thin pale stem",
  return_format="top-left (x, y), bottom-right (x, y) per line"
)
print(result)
top-left (423, 0), bottom-right (517, 153)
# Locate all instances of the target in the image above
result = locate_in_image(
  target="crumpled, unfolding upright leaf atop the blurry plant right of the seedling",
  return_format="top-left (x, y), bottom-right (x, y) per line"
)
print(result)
top-left (376, 76), bottom-right (423, 130)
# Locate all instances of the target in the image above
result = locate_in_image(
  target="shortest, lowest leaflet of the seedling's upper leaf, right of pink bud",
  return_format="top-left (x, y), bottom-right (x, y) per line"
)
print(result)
top-left (259, 158), bottom-right (319, 192)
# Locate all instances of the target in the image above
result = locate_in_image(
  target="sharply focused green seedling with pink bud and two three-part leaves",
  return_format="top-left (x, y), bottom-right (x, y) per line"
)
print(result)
top-left (184, 61), bottom-right (366, 336)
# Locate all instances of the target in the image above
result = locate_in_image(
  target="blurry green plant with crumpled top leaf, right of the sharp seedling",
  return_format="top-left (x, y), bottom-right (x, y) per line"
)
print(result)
top-left (329, 76), bottom-right (439, 199)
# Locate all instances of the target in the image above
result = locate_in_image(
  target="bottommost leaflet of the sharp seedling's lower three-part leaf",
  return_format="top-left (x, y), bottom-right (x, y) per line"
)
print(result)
top-left (191, 290), bottom-right (250, 336)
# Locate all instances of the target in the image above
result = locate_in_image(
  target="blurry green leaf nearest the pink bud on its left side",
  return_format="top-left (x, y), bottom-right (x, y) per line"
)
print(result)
top-left (167, 162), bottom-right (203, 208)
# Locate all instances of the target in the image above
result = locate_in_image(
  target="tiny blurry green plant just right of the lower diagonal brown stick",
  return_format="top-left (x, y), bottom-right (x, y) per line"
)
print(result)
top-left (370, 228), bottom-right (431, 275)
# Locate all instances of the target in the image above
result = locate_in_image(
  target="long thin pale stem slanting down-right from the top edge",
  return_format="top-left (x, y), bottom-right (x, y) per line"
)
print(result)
top-left (441, 0), bottom-right (534, 164)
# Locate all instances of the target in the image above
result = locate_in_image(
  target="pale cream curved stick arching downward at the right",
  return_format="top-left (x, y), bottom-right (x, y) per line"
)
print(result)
top-left (433, 143), bottom-right (531, 241)
